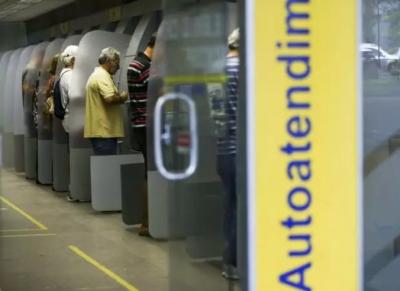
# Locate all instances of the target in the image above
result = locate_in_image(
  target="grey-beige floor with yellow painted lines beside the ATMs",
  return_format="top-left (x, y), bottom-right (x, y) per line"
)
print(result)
top-left (0, 170), bottom-right (238, 291)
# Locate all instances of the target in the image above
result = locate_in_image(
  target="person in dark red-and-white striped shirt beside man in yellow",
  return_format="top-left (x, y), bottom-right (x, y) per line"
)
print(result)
top-left (127, 35), bottom-right (156, 236)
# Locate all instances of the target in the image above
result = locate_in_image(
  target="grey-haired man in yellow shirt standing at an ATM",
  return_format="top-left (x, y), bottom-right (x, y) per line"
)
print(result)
top-left (84, 47), bottom-right (128, 155)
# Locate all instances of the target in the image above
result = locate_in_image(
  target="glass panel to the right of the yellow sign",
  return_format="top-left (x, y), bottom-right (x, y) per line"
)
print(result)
top-left (360, 0), bottom-right (400, 291)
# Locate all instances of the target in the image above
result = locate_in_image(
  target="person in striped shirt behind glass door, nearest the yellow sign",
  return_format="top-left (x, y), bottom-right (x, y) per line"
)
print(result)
top-left (211, 28), bottom-right (240, 280)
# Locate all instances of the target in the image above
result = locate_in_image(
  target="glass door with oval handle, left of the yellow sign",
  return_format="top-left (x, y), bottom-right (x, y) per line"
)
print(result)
top-left (148, 0), bottom-right (240, 291)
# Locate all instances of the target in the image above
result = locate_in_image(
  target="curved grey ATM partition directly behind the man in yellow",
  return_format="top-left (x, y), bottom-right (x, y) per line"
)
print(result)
top-left (70, 30), bottom-right (130, 201)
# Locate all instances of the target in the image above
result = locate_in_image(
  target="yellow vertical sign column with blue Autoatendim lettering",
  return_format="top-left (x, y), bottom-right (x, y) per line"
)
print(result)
top-left (246, 0), bottom-right (362, 291)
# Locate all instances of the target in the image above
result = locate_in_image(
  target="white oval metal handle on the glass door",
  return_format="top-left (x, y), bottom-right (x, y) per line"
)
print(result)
top-left (154, 93), bottom-right (198, 180)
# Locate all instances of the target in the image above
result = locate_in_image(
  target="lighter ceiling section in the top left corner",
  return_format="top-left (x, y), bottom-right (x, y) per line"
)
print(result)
top-left (0, 0), bottom-right (75, 22)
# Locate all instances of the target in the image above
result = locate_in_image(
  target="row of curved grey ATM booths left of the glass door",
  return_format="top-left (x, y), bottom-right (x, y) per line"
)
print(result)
top-left (0, 12), bottom-right (160, 200)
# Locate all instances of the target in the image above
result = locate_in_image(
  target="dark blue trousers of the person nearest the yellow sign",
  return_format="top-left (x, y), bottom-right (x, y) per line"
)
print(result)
top-left (217, 154), bottom-right (237, 267)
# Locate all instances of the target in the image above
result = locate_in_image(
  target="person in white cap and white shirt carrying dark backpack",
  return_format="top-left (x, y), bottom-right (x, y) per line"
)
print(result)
top-left (60, 45), bottom-right (78, 133)
